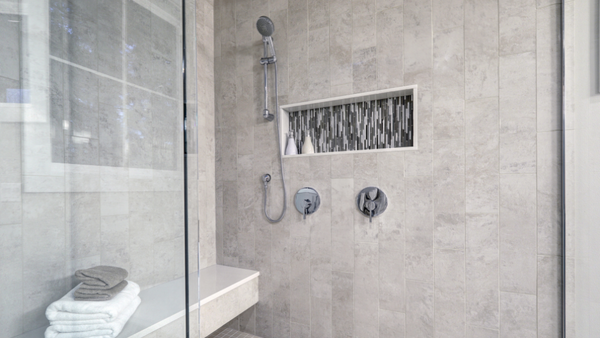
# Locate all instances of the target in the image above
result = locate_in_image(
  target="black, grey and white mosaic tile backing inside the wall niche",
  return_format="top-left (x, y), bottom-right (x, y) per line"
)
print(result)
top-left (289, 95), bottom-right (414, 153)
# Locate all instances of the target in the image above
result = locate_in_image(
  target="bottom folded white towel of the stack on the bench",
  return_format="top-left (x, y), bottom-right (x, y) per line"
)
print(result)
top-left (45, 296), bottom-right (142, 338)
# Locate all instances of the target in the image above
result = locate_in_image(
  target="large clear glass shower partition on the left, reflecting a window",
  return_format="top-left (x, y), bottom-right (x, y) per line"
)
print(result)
top-left (0, 0), bottom-right (198, 338)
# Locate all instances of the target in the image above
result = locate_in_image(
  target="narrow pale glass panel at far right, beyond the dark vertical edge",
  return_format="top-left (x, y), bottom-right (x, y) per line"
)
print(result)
top-left (564, 0), bottom-right (600, 338)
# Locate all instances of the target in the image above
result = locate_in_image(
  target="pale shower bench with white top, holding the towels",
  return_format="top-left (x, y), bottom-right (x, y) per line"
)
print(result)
top-left (17, 265), bottom-right (259, 338)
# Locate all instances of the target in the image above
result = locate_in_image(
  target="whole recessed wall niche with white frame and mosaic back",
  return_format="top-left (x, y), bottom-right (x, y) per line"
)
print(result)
top-left (279, 85), bottom-right (418, 157)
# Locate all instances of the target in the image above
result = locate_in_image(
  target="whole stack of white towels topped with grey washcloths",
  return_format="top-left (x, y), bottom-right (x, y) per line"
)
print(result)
top-left (45, 266), bottom-right (142, 338)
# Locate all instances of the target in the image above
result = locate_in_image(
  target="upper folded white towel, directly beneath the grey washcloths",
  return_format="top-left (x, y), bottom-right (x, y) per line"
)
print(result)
top-left (46, 281), bottom-right (140, 325)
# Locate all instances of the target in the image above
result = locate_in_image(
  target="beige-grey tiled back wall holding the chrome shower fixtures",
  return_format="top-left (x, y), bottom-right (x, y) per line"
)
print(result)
top-left (215, 0), bottom-right (560, 338)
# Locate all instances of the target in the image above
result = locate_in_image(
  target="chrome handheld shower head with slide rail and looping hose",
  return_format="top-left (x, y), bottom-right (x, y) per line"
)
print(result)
top-left (256, 16), bottom-right (287, 223)
